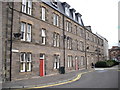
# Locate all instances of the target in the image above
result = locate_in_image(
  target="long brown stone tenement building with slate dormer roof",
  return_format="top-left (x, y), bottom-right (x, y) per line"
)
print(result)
top-left (2, 0), bottom-right (103, 81)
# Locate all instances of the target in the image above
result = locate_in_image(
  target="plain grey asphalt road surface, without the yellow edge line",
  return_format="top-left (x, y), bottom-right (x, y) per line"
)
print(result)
top-left (49, 70), bottom-right (118, 88)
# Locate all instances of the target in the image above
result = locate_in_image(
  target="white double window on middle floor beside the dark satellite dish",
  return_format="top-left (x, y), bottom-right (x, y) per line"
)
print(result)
top-left (21, 22), bottom-right (32, 42)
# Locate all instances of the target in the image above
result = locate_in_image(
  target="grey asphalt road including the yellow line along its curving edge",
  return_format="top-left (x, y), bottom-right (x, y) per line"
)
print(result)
top-left (2, 68), bottom-right (120, 90)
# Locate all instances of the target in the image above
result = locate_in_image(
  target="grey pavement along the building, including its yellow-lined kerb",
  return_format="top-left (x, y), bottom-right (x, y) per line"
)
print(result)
top-left (2, 66), bottom-right (118, 88)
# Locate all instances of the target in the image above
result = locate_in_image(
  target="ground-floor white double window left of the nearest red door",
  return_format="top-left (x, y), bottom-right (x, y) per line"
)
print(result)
top-left (20, 53), bottom-right (32, 72)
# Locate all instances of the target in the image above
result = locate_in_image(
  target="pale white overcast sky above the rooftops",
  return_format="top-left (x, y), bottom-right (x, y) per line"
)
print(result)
top-left (60, 0), bottom-right (120, 48)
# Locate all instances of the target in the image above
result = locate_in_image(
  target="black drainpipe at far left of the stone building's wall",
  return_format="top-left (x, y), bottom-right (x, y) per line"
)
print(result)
top-left (8, 2), bottom-right (14, 81)
